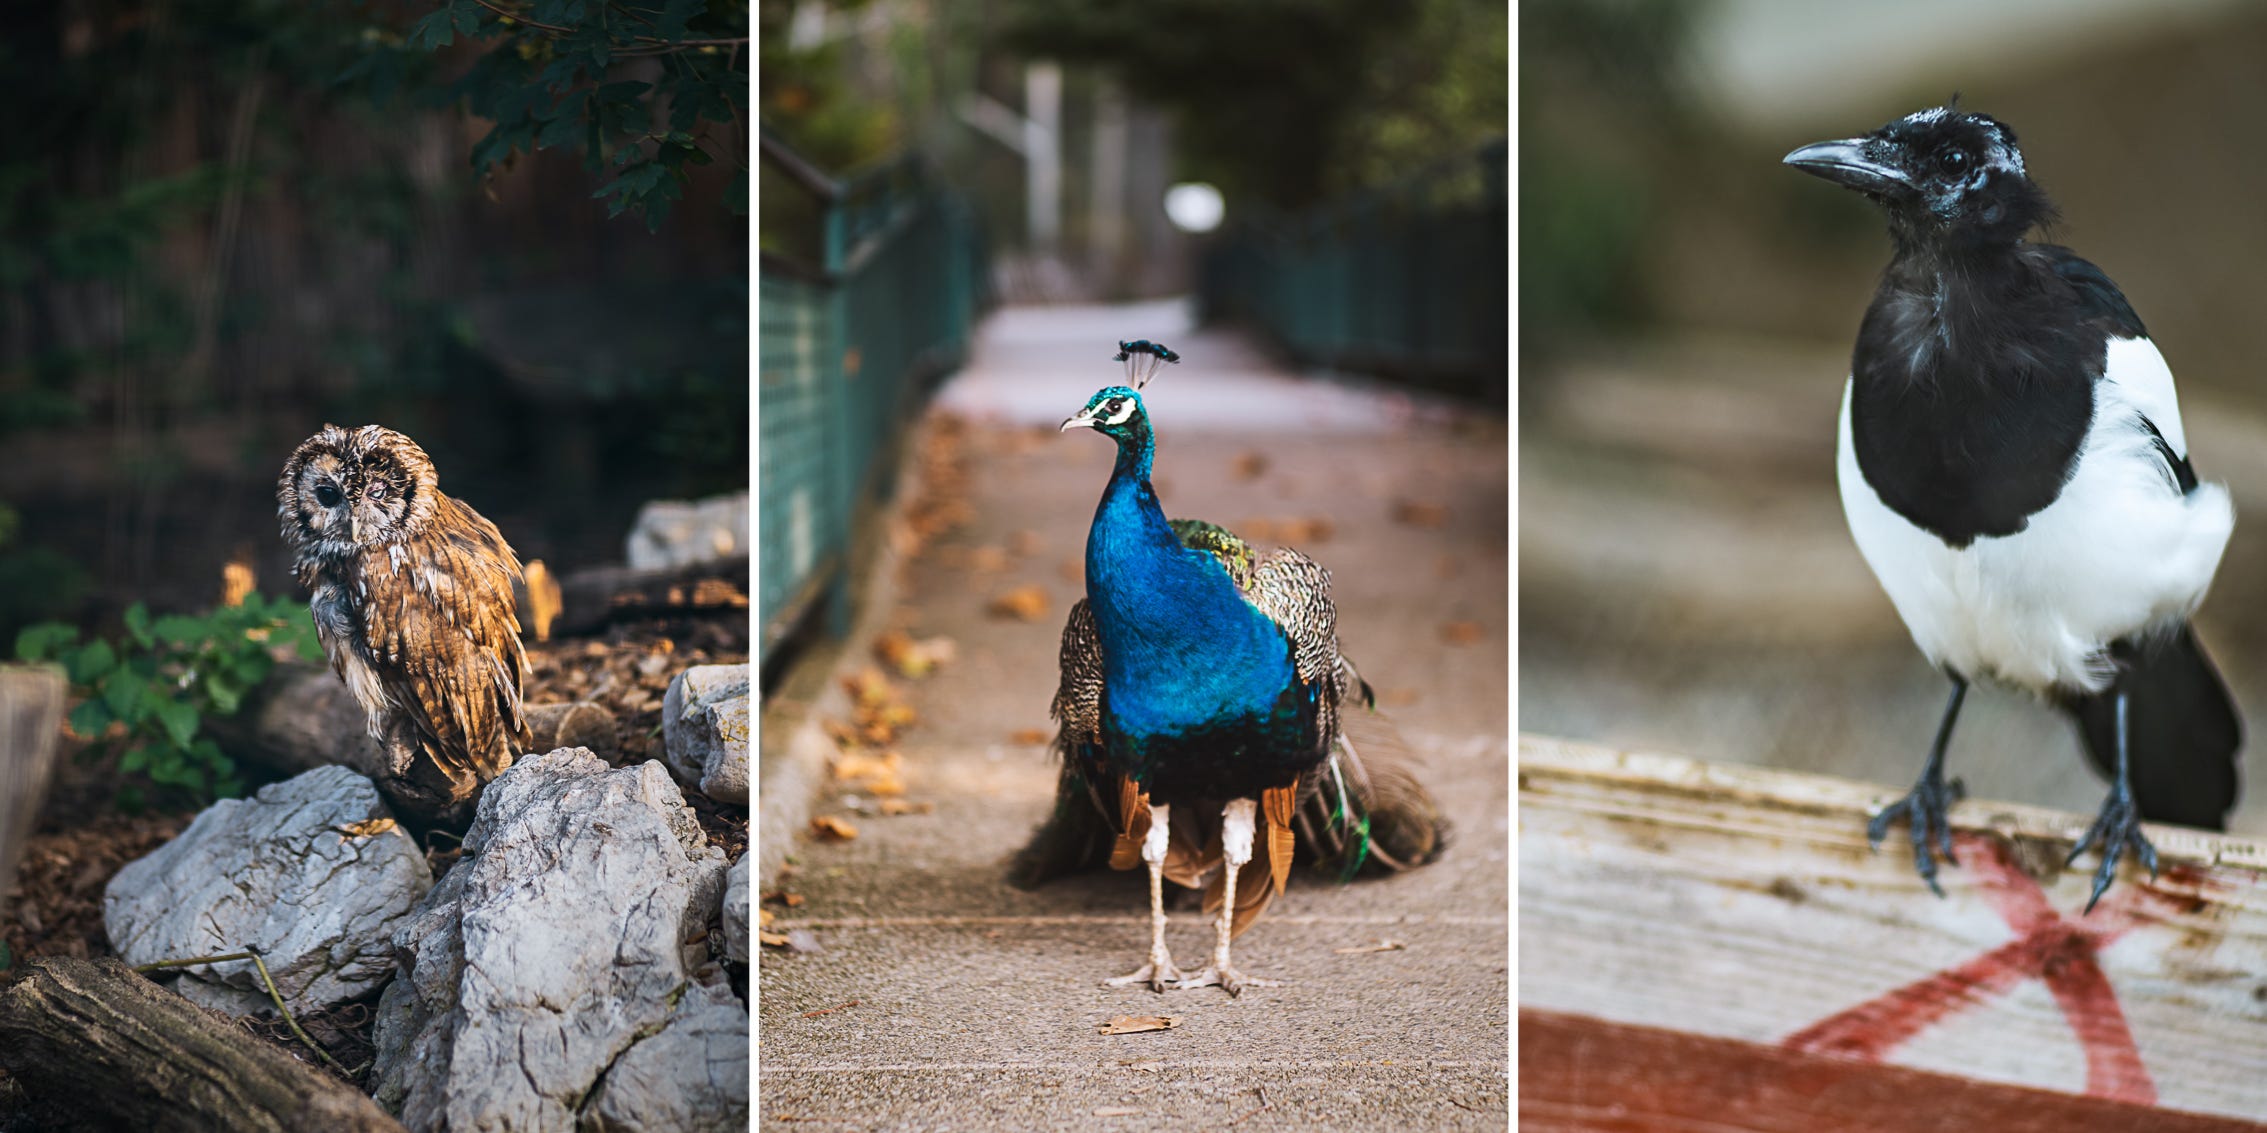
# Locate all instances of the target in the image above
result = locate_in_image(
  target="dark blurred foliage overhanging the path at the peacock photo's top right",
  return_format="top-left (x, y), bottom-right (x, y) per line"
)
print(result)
top-left (1007, 0), bottom-right (1510, 208)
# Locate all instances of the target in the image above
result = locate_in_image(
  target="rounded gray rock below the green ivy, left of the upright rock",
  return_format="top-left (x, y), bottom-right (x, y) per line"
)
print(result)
top-left (102, 766), bottom-right (433, 1015)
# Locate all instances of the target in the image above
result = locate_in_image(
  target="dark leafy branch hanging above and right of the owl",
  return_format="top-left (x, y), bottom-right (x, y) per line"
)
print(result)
top-left (342, 0), bottom-right (748, 231)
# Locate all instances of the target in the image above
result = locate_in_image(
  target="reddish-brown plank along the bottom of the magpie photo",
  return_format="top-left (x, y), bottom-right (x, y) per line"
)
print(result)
top-left (1519, 1008), bottom-right (2267, 1133)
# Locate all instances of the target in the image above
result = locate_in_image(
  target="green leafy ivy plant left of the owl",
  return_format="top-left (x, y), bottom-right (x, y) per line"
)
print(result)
top-left (16, 591), bottom-right (322, 807)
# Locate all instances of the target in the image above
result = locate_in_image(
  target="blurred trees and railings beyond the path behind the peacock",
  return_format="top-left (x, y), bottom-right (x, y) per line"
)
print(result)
top-left (757, 0), bottom-right (1510, 675)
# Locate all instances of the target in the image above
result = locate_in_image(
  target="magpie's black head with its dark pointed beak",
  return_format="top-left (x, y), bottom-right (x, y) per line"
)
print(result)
top-left (1784, 104), bottom-right (2054, 245)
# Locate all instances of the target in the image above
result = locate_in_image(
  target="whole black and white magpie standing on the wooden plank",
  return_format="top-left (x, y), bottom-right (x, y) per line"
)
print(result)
top-left (1784, 106), bottom-right (2242, 913)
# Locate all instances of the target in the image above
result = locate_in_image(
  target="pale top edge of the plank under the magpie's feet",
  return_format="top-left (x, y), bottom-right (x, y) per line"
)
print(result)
top-left (1519, 732), bottom-right (2267, 872)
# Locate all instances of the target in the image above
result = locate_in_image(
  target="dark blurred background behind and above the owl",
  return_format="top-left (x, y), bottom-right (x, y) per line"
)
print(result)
top-left (0, 0), bottom-right (748, 641)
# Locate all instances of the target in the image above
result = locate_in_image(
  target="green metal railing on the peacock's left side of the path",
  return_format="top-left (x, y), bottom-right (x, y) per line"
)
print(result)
top-left (757, 136), bottom-right (986, 653)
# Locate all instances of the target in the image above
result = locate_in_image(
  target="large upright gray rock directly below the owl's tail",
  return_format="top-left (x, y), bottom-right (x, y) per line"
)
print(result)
top-left (372, 748), bottom-right (725, 1133)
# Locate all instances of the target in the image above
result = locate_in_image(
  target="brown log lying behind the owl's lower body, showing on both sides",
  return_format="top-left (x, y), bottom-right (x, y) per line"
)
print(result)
top-left (206, 664), bottom-right (621, 825)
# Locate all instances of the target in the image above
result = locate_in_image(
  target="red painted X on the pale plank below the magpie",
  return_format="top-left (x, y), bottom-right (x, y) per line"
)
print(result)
top-left (1784, 834), bottom-right (2201, 1106)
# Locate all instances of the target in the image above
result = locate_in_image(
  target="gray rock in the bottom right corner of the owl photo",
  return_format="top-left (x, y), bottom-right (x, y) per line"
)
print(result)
top-left (578, 983), bottom-right (748, 1133)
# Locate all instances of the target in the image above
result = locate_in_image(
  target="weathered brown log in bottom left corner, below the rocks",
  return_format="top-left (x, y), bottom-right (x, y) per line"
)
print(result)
top-left (0, 959), bottom-right (404, 1133)
